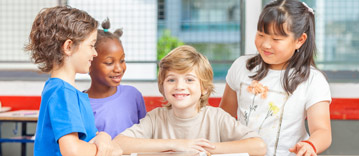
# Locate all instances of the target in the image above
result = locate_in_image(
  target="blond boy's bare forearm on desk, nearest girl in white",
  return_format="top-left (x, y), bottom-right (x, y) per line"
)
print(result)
top-left (202, 138), bottom-right (267, 155)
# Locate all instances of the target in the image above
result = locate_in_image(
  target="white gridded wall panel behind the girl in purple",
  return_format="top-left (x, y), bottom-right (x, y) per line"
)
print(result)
top-left (67, 0), bottom-right (157, 80)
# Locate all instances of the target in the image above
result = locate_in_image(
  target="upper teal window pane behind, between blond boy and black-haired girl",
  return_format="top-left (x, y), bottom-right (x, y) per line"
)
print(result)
top-left (181, 0), bottom-right (240, 31)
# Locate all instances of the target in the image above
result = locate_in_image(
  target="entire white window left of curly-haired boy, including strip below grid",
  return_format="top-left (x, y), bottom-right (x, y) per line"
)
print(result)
top-left (0, 0), bottom-right (57, 80)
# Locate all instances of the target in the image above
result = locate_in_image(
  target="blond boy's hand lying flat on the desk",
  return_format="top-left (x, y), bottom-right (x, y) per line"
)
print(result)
top-left (170, 139), bottom-right (215, 153)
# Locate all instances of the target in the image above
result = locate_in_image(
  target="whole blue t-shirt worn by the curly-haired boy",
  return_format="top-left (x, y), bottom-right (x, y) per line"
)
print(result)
top-left (34, 78), bottom-right (97, 156)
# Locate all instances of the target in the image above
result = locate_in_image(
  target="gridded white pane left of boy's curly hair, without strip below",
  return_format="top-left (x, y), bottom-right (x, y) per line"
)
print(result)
top-left (0, 0), bottom-right (58, 63)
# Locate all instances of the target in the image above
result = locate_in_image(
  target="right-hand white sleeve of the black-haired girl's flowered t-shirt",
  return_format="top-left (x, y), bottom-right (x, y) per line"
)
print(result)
top-left (306, 70), bottom-right (332, 109)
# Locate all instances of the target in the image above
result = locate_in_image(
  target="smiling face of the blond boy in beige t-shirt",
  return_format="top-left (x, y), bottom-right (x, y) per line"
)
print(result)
top-left (163, 70), bottom-right (202, 112)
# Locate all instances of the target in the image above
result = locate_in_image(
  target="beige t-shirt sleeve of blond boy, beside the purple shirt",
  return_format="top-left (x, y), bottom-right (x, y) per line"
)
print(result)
top-left (121, 111), bottom-right (154, 139)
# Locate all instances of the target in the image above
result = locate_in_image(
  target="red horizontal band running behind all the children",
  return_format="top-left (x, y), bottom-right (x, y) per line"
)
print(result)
top-left (0, 96), bottom-right (359, 120)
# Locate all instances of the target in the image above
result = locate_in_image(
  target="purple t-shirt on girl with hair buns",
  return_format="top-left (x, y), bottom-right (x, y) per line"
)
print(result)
top-left (90, 85), bottom-right (146, 138)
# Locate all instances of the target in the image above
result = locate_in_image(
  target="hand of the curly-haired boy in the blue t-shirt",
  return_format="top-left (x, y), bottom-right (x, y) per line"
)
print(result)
top-left (89, 132), bottom-right (114, 156)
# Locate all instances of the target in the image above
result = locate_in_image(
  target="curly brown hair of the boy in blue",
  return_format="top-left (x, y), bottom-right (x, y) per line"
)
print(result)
top-left (25, 6), bottom-right (98, 72)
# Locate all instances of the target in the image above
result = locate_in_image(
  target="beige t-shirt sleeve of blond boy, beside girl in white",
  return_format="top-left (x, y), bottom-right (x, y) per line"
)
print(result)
top-left (218, 110), bottom-right (260, 142)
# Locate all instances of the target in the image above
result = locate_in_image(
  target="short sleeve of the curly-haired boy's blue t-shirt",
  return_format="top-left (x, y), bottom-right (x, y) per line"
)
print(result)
top-left (47, 87), bottom-right (86, 141)
